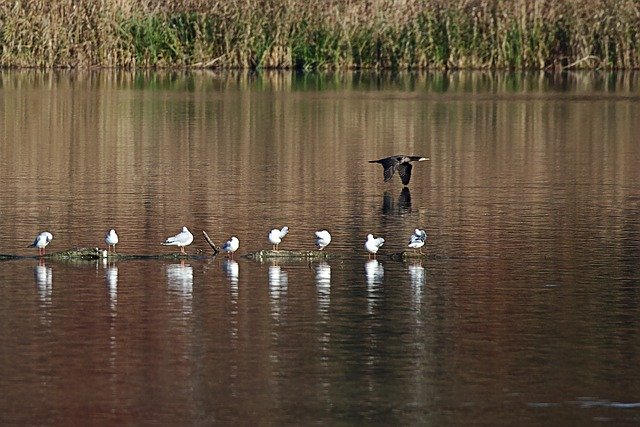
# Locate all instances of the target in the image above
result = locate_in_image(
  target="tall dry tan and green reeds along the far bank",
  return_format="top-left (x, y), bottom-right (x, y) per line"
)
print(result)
top-left (0, 0), bottom-right (640, 70)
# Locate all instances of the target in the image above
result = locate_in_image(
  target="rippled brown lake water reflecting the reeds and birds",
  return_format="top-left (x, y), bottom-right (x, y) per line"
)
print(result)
top-left (0, 71), bottom-right (640, 425)
